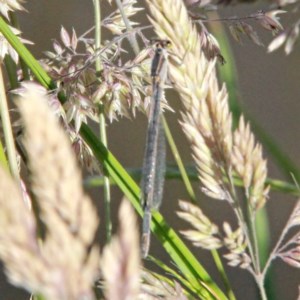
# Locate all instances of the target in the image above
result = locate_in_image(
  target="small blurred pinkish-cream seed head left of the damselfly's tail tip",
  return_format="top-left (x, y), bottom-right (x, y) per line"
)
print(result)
top-left (101, 200), bottom-right (140, 300)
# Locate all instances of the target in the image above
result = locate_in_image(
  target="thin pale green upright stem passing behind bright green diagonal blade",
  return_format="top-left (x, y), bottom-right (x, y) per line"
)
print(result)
top-left (93, 0), bottom-right (112, 241)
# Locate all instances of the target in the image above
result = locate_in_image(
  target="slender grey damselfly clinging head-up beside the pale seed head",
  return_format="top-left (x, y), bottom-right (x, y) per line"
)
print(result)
top-left (141, 40), bottom-right (170, 258)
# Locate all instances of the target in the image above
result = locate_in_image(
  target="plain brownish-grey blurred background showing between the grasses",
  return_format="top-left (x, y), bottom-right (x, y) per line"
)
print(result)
top-left (0, 0), bottom-right (300, 300)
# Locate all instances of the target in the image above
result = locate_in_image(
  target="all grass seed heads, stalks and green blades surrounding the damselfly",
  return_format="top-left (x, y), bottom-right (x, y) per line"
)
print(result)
top-left (0, 0), bottom-right (300, 300)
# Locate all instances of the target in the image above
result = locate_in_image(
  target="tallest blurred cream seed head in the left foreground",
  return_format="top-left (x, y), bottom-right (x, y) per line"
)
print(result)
top-left (17, 86), bottom-right (99, 299)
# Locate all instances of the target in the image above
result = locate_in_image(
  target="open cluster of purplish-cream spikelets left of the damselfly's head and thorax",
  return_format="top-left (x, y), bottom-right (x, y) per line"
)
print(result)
top-left (43, 28), bottom-right (157, 123)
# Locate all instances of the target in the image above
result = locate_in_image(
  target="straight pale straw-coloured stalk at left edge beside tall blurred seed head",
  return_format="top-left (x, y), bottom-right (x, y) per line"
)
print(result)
top-left (0, 67), bottom-right (20, 182)
